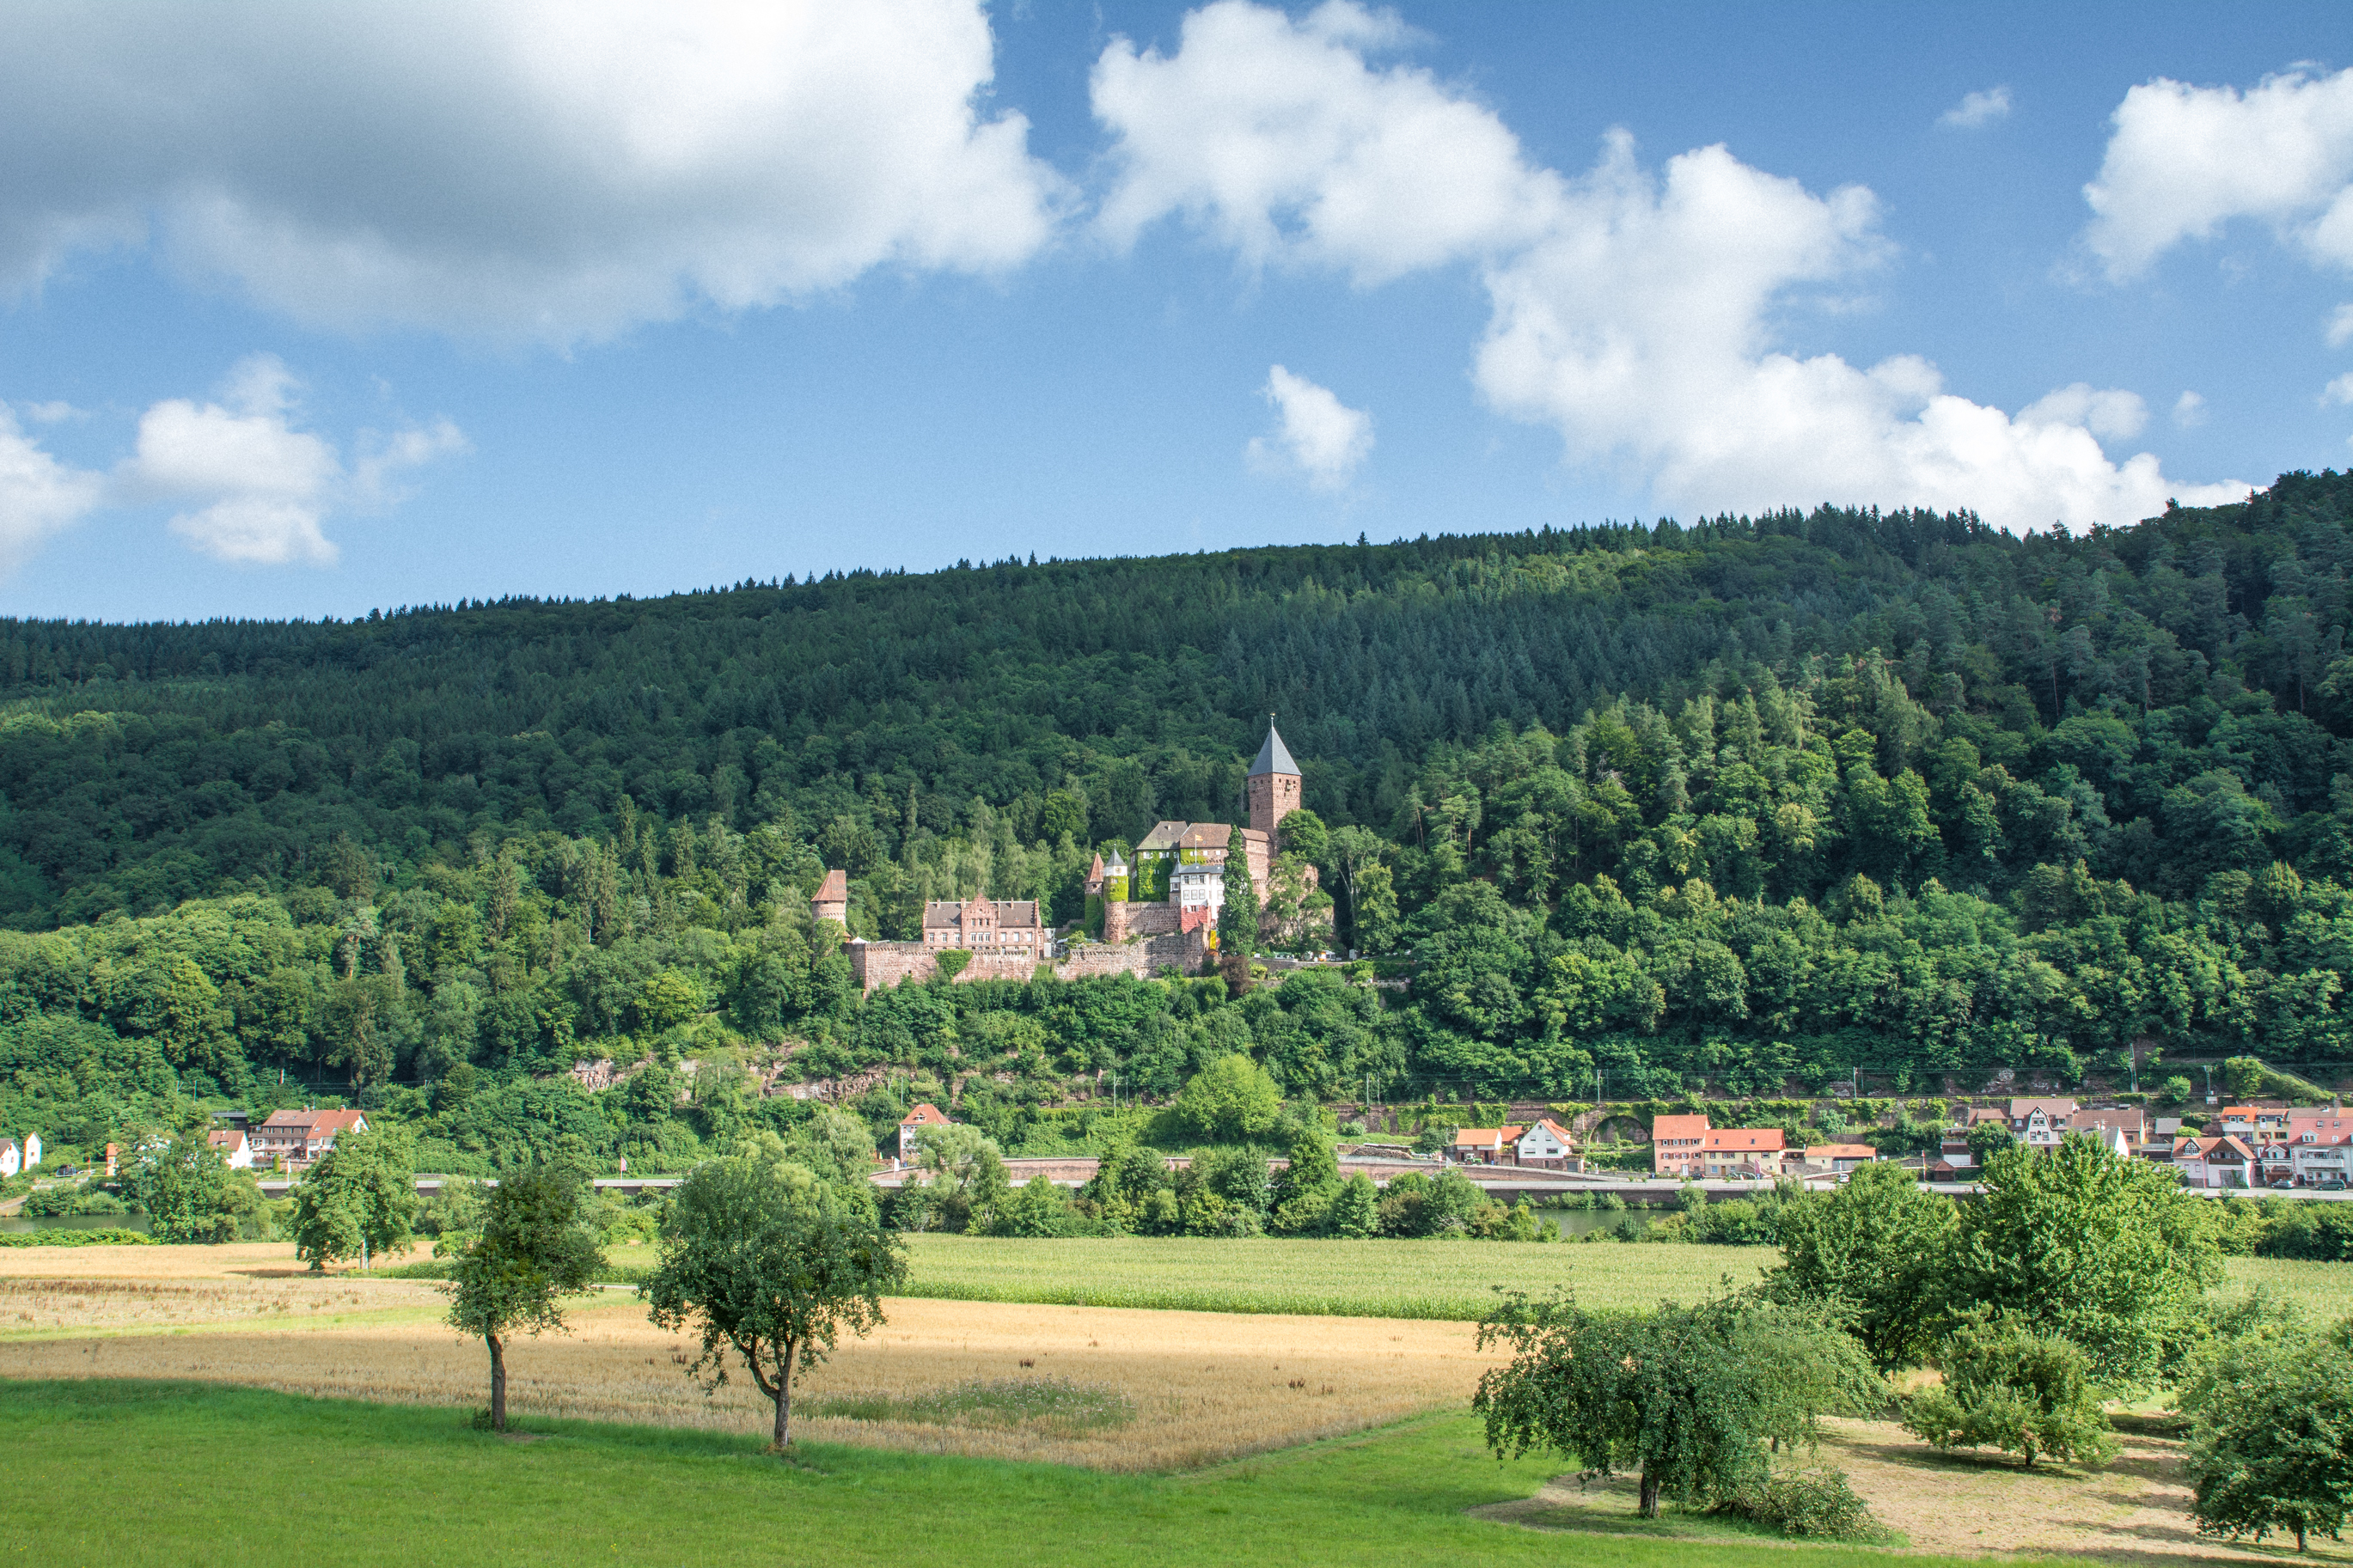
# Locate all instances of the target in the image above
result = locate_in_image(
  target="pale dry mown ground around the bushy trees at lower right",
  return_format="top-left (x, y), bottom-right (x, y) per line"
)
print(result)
top-left (1473, 1420), bottom-right (2353, 1564)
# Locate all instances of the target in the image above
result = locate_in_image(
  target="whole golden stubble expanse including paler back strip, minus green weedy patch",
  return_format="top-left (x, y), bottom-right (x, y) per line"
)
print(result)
top-left (0, 1248), bottom-right (1494, 1469)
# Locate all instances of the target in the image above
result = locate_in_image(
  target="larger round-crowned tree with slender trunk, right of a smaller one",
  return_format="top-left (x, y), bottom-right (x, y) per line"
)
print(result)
top-left (645, 1156), bottom-right (906, 1453)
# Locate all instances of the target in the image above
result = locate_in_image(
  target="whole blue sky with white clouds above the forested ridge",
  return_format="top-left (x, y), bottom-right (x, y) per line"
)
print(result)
top-left (0, 0), bottom-right (2353, 619)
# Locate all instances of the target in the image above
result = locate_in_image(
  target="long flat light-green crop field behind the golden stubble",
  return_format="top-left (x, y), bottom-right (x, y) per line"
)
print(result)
top-left (903, 1234), bottom-right (2353, 1319)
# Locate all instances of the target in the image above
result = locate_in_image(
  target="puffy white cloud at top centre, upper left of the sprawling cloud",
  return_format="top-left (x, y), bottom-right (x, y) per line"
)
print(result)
top-left (1094, 0), bottom-right (1560, 284)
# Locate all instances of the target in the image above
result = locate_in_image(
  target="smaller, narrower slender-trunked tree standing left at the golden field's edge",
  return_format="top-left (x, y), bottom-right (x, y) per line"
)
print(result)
top-left (449, 1166), bottom-right (605, 1431)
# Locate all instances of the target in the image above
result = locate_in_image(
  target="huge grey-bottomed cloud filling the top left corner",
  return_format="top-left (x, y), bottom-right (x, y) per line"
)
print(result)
top-left (0, 0), bottom-right (1061, 343)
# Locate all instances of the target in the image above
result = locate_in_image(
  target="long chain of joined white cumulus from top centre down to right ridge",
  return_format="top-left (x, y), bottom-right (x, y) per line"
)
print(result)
top-left (1094, 0), bottom-right (2245, 529)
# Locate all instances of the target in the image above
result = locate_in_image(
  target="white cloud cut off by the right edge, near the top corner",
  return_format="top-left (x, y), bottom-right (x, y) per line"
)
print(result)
top-left (2082, 70), bottom-right (2353, 278)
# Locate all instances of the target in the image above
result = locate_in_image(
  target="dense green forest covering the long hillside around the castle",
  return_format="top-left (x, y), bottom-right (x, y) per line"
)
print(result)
top-left (0, 473), bottom-right (2353, 1163)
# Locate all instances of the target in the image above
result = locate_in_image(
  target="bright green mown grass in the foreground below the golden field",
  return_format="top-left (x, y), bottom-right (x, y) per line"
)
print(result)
top-left (0, 1382), bottom-right (2032, 1568)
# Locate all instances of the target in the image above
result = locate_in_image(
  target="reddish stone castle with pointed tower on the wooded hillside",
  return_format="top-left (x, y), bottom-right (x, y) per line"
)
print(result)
top-left (810, 715), bottom-right (1313, 992)
